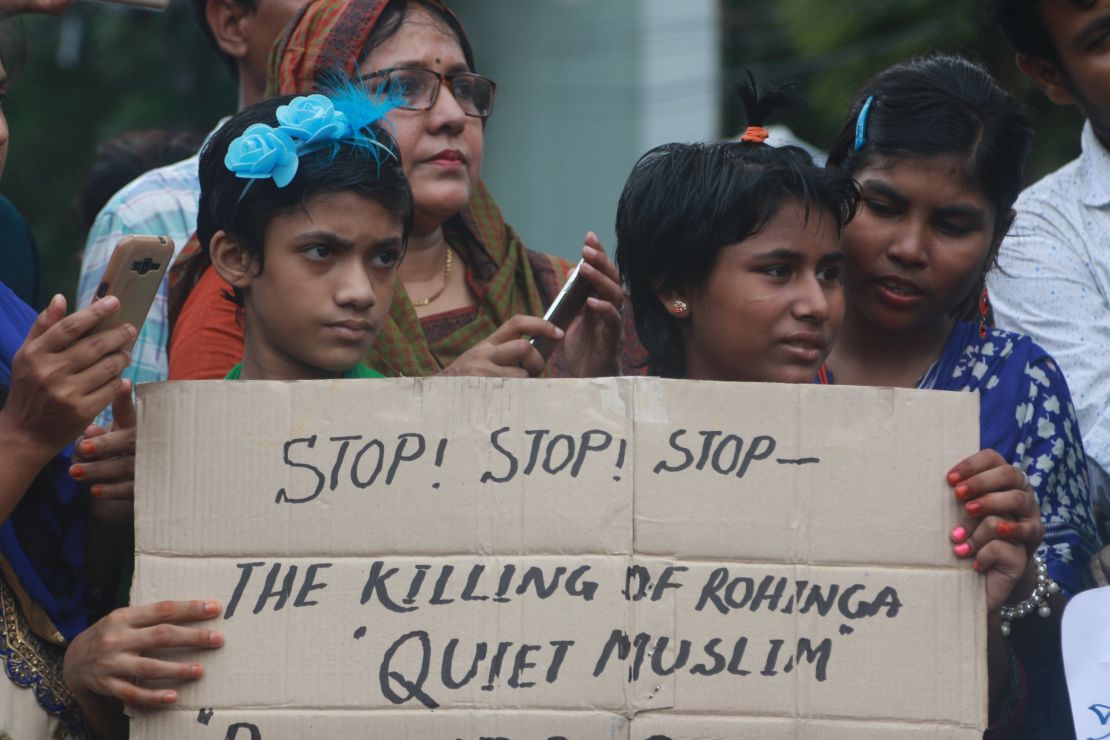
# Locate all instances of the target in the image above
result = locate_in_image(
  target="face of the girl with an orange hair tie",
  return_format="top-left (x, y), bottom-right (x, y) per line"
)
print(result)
top-left (664, 203), bottom-right (844, 383)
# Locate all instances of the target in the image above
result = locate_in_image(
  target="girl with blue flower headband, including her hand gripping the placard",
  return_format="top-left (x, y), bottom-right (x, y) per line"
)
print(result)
top-left (52, 88), bottom-right (412, 737)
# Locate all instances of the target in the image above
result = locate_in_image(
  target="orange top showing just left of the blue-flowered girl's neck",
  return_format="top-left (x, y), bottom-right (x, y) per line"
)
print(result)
top-left (170, 267), bottom-right (243, 381)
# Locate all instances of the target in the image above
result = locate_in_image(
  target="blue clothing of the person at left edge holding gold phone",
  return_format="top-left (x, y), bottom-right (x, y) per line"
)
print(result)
top-left (0, 283), bottom-right (88, 643)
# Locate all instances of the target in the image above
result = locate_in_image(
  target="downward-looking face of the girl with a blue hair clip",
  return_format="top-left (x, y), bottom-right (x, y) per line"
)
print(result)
top-left (844, 158), bottom-right (995, 331)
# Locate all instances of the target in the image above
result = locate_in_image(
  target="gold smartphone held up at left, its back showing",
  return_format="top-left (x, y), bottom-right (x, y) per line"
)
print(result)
top-left (92, 235), bottom-right (173, 331)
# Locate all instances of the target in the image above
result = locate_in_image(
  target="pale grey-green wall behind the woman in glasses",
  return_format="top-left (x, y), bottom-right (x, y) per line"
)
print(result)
top-left (451, 0), bottom-right (723, 265)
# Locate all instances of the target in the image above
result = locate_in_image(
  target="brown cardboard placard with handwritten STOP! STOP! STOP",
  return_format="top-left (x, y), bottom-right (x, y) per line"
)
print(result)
top-left (132, 378), bottom-right (987, 740)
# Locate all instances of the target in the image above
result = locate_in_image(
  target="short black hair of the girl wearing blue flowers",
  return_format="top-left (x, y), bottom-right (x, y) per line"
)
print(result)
top-left (196, 95), bottom-right (413, 305)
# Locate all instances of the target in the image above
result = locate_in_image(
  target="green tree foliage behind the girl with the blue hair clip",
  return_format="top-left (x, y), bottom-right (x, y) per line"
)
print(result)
top-left (724, 0), bottom-right (1082, 180)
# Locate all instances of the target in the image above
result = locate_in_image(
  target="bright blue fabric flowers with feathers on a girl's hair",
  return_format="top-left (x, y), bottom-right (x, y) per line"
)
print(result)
top-left (223, 75), bottom-right (403, 188)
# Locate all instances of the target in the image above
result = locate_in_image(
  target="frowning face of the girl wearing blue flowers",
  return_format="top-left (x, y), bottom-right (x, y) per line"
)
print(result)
top-left (243, 192), bottom-right (404, 381)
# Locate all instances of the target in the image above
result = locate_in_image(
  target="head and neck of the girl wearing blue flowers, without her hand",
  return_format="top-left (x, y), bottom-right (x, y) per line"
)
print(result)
top-left (196, 85), bottom-right (413, 381)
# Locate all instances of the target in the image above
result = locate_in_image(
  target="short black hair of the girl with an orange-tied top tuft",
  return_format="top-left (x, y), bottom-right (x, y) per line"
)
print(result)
top-left (616, 82), bottom-right (859, 377)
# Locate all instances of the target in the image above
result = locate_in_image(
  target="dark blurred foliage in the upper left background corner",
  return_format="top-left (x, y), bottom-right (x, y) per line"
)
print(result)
top-left (0, 0), bottom-right (235, 306)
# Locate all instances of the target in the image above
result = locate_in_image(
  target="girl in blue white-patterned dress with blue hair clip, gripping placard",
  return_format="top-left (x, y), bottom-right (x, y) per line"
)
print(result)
top-left (819, 55), bottom-right (1099, 738)
